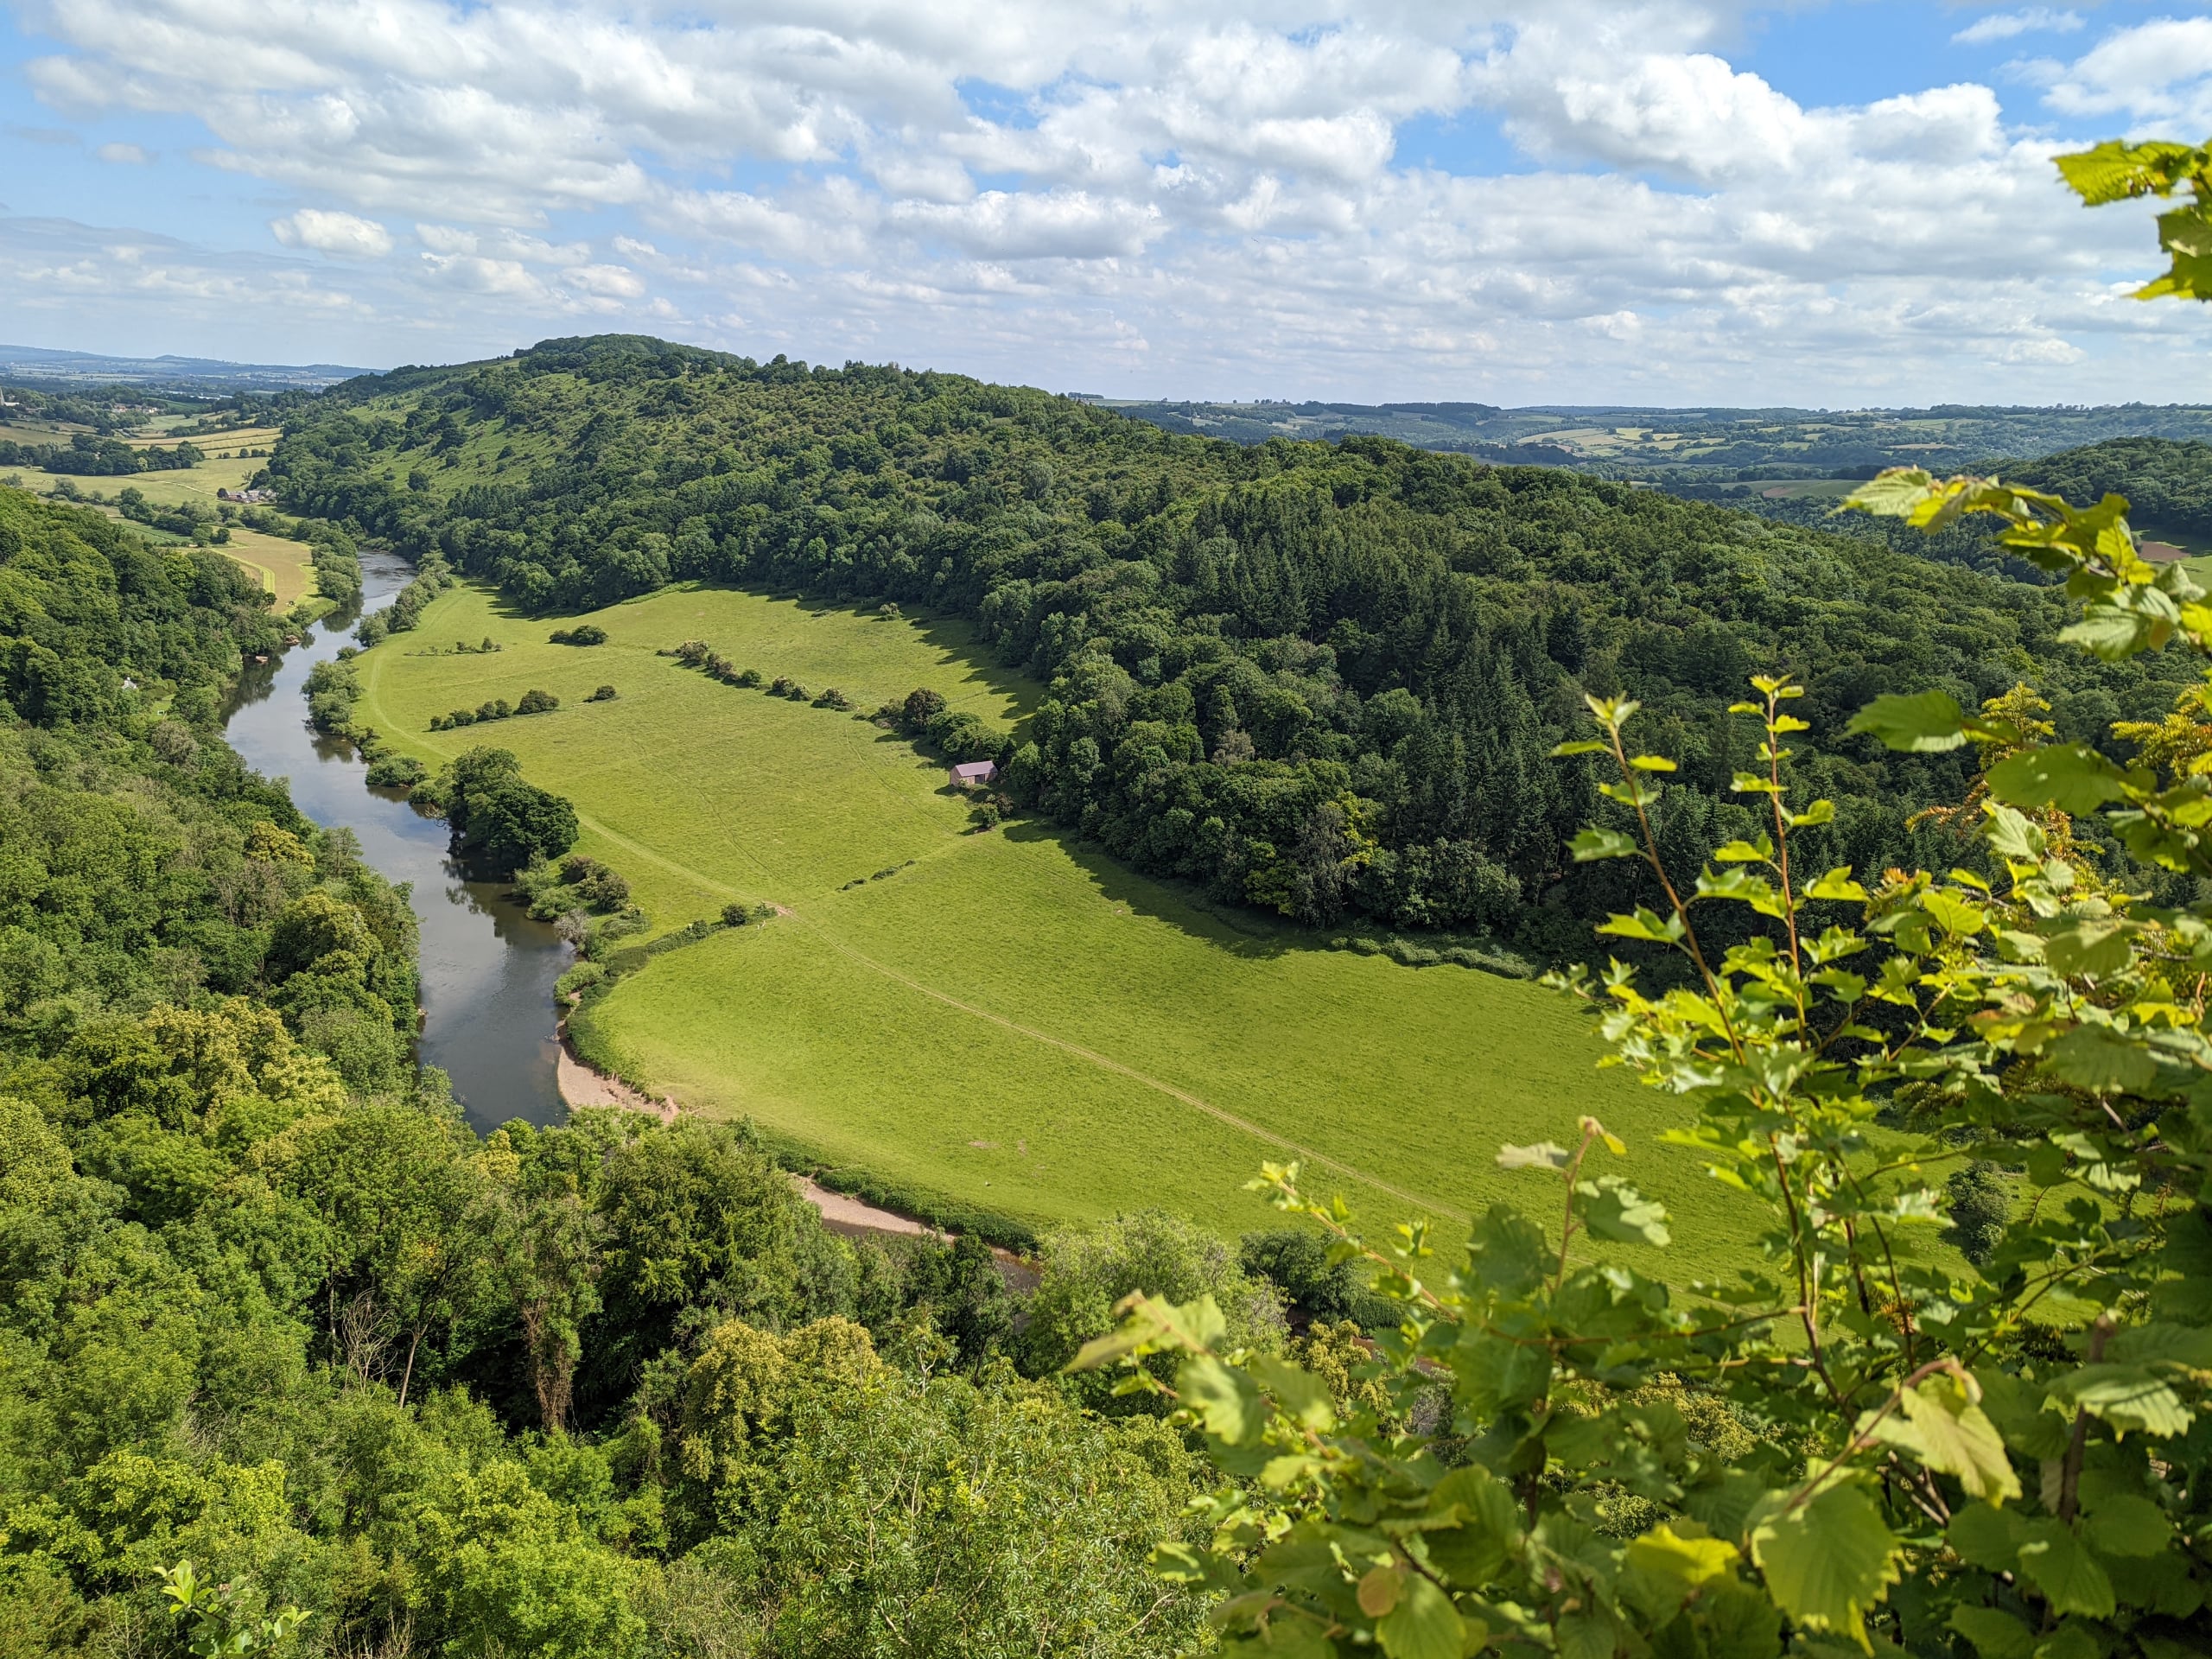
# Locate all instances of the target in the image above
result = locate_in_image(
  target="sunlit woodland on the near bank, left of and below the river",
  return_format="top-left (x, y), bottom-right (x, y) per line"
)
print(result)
top-left (0, 477), bottom-right (1389, 1659)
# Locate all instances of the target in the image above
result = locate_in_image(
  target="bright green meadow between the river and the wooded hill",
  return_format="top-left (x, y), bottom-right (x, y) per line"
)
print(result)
top-left (359, 588), bottom-right (1778, 1269)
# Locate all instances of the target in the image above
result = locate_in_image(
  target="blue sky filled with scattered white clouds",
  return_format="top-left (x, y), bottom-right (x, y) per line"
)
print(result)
top-left (0, 0), bottom-right (2212, 407)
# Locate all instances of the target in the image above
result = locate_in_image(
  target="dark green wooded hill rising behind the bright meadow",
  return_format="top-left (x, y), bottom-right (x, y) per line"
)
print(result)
top-left (270, 336), bottom-right (2188, 956)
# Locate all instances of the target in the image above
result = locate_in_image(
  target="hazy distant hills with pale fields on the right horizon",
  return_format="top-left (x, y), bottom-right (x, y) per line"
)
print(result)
top-left (1106, 398), bottom-right (2212, 485)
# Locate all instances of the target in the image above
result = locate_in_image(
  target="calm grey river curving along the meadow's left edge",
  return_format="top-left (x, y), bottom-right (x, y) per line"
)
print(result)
top-left (224, 553), bottom-right (570, 1130)
